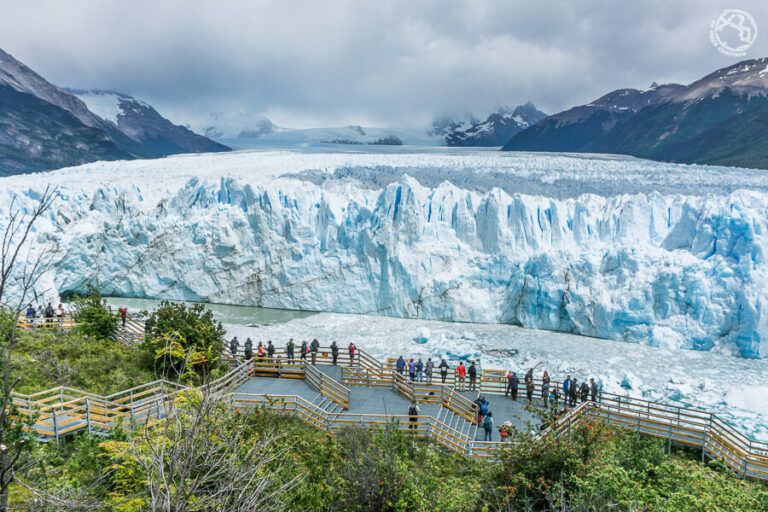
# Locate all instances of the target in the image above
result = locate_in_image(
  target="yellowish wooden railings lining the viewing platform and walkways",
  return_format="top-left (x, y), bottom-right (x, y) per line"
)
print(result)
top-left (13, 338), bottom-right (768, 480)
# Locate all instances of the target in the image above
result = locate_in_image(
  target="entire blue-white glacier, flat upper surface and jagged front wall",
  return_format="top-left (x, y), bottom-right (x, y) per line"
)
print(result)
top-left (0, 149), bottom-right (768, 358)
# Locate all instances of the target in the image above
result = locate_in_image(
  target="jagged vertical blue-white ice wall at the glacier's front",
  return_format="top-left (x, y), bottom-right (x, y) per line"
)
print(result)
top-left (27, 169), bottom-right (768, 358)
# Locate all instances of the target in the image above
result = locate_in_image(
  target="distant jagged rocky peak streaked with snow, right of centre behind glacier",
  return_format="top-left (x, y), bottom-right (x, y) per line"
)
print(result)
top-left (445, 101), bottom-right (547, 147)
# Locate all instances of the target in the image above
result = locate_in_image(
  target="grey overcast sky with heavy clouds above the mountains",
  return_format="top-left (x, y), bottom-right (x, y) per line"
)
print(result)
top-left (0, 0), bottom-right (768, 127)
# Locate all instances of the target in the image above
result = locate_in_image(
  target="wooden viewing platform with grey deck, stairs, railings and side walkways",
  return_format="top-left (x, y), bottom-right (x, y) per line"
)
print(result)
top-left (13, 347), bottom-right (768, 481)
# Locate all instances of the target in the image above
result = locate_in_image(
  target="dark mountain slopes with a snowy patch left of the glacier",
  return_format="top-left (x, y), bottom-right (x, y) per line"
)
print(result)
top-left (0, 50), bottom-right (229, 176)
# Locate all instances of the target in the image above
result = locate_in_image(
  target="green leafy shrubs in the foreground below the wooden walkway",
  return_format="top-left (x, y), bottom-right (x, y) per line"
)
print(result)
top-left (15, 408), bottom-right (768, 512)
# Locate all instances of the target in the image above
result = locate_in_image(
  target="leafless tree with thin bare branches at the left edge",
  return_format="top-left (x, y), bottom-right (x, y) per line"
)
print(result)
top-left (0, 187), bottom-right (58, 510)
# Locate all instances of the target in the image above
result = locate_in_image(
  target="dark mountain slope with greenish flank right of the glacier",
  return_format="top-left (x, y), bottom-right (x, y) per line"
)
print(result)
top-left (503, 58), bottom-right (768, 168)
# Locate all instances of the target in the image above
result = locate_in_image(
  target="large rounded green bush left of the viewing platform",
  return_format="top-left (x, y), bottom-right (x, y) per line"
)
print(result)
top-left (144, 301), bottom-right (226, 383)
